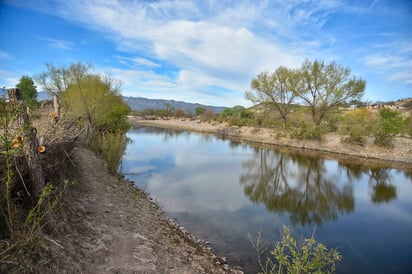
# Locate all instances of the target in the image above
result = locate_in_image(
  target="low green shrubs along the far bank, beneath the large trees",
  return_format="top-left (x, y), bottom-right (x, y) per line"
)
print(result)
top-left (133, 100), bottom-right (412, 148)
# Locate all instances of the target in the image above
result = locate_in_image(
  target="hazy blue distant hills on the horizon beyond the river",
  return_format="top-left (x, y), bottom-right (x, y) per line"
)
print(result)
top-left (122, 96), bottom-right (226, 113)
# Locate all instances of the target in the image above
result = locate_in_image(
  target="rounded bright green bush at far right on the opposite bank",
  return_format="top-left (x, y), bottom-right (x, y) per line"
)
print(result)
top-left (375, 109), bottom-right (405, 147)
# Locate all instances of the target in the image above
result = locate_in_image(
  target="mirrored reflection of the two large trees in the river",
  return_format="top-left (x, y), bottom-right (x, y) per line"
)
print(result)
top-left (240, 149), bottom-right (354, 225)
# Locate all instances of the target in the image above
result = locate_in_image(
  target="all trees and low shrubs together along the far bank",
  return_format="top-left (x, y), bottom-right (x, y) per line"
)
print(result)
top-left (135, 60), bottom-right (412, 150)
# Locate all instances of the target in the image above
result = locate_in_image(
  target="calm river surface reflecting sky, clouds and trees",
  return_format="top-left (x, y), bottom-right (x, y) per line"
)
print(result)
top-left (122, 127), bottom-right (412, 273)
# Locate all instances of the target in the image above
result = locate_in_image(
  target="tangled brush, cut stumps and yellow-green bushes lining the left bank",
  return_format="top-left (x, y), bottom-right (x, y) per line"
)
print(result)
top-left (0, 64), bottom-right (130, 273)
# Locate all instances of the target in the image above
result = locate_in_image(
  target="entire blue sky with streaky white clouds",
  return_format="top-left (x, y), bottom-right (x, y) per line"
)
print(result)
top-left (0, 0), bottom-right (412, 106)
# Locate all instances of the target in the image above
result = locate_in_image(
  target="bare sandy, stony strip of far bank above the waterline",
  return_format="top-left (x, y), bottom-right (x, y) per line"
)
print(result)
top-left (129, 116), bottom-right (412, 170)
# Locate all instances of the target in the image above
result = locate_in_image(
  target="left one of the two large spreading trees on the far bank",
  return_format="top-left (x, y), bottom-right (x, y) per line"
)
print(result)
top-left (245, 66), bottom-right (298, 128)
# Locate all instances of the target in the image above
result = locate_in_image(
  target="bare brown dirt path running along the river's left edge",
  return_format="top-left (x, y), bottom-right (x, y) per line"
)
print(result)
top-left (49, 148), bottom-right (242, 274)
